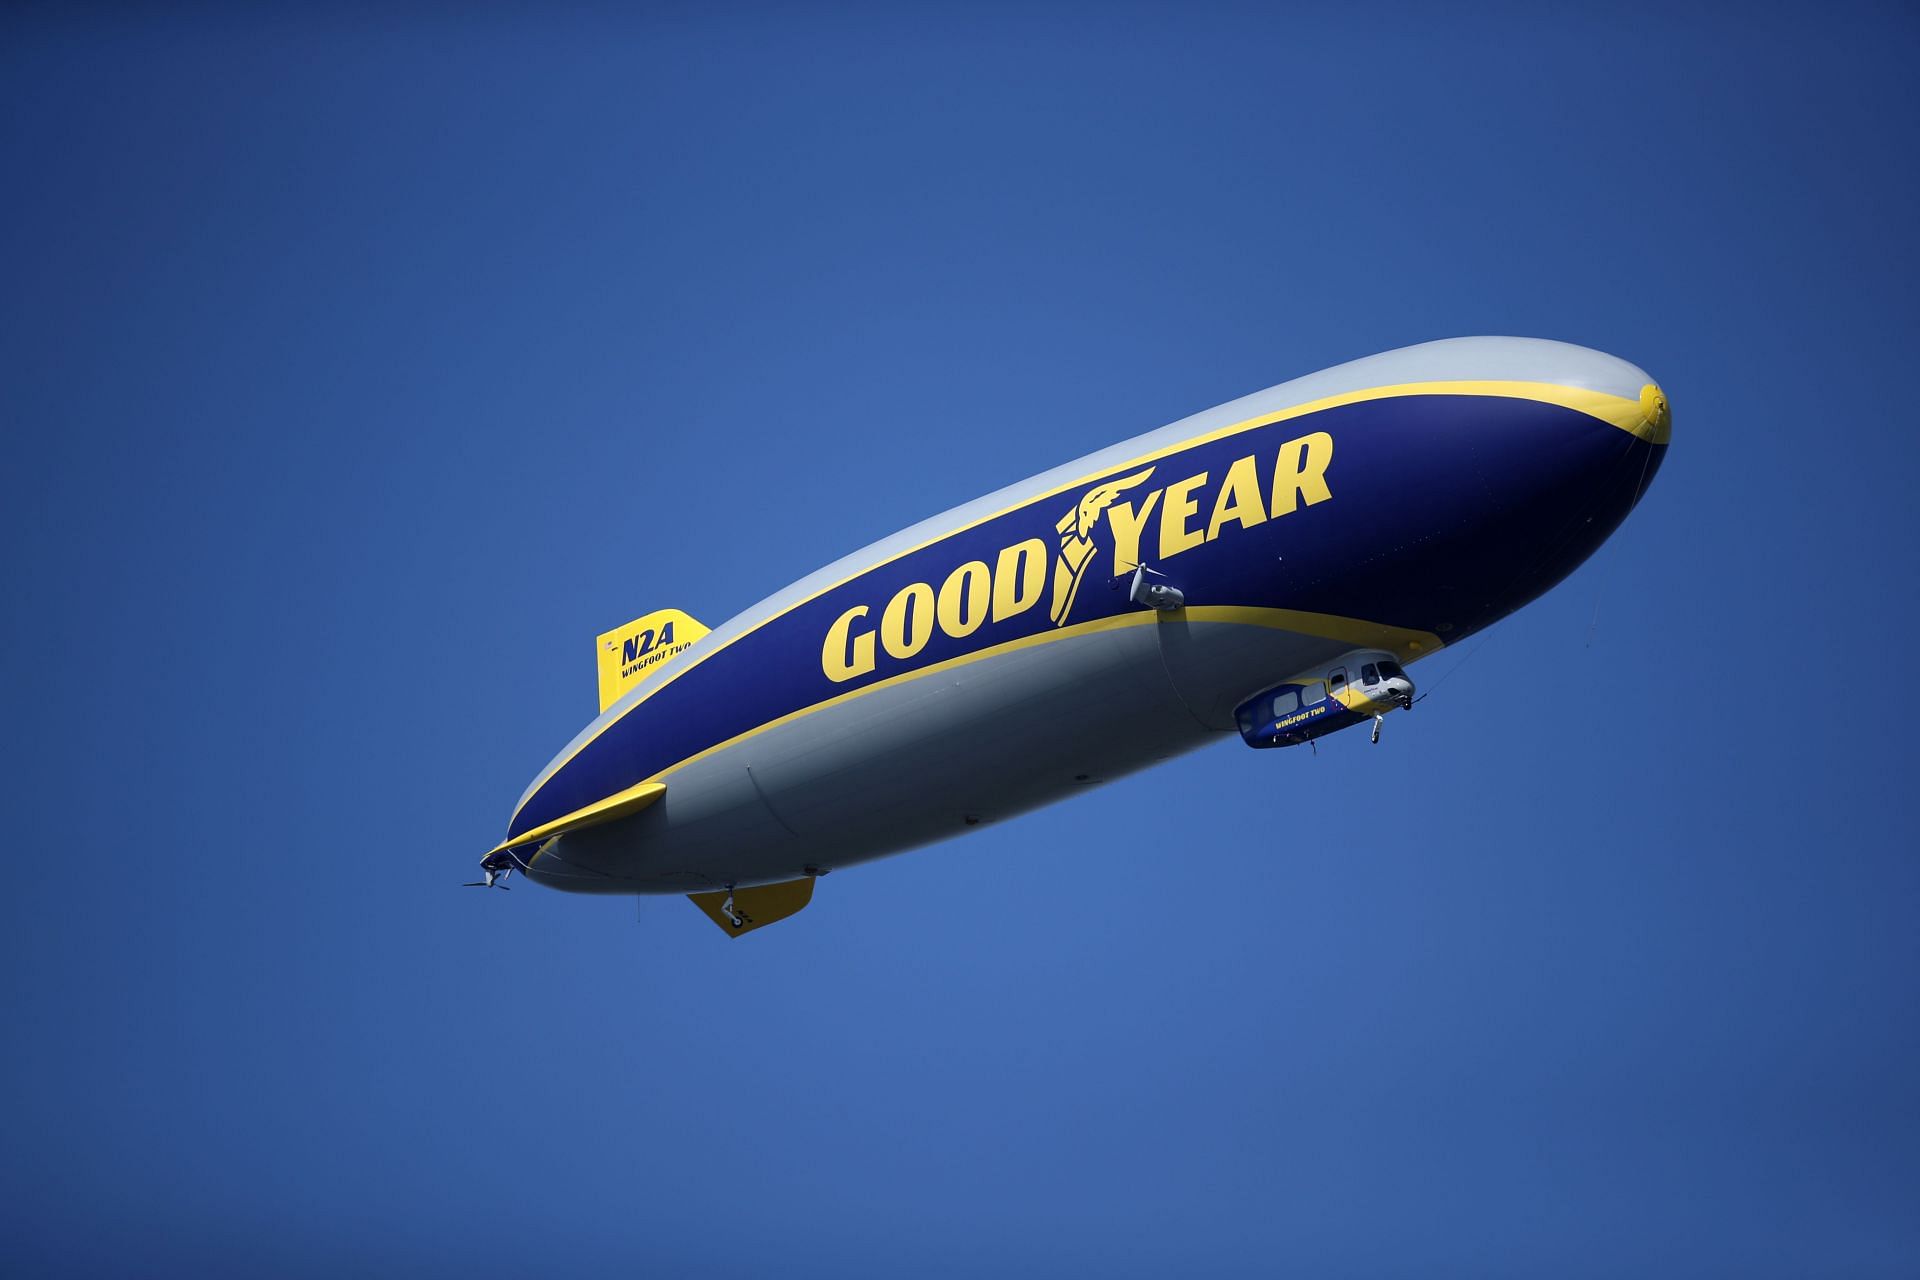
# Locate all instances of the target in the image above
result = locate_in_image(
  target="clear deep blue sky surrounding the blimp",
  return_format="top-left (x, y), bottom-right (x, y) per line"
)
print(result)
top-left (0, 6), bottom-right (1920, 1276)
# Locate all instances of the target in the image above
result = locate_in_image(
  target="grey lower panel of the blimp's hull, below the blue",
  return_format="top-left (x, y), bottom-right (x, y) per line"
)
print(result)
top-left (555, 614), bottom-right (1374, 892)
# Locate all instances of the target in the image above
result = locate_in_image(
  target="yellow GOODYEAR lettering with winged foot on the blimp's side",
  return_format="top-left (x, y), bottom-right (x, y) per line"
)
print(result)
top-left (820, 432), bottom-right (1332, 683)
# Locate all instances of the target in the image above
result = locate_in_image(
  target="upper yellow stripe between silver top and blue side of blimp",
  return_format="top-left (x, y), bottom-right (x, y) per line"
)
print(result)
top-left (507, 382), bottom-right (1635, 825)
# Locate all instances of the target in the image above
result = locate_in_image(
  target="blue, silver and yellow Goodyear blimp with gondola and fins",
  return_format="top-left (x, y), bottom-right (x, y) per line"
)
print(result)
top-left (474, 338), bottom-right (1672, 936)
